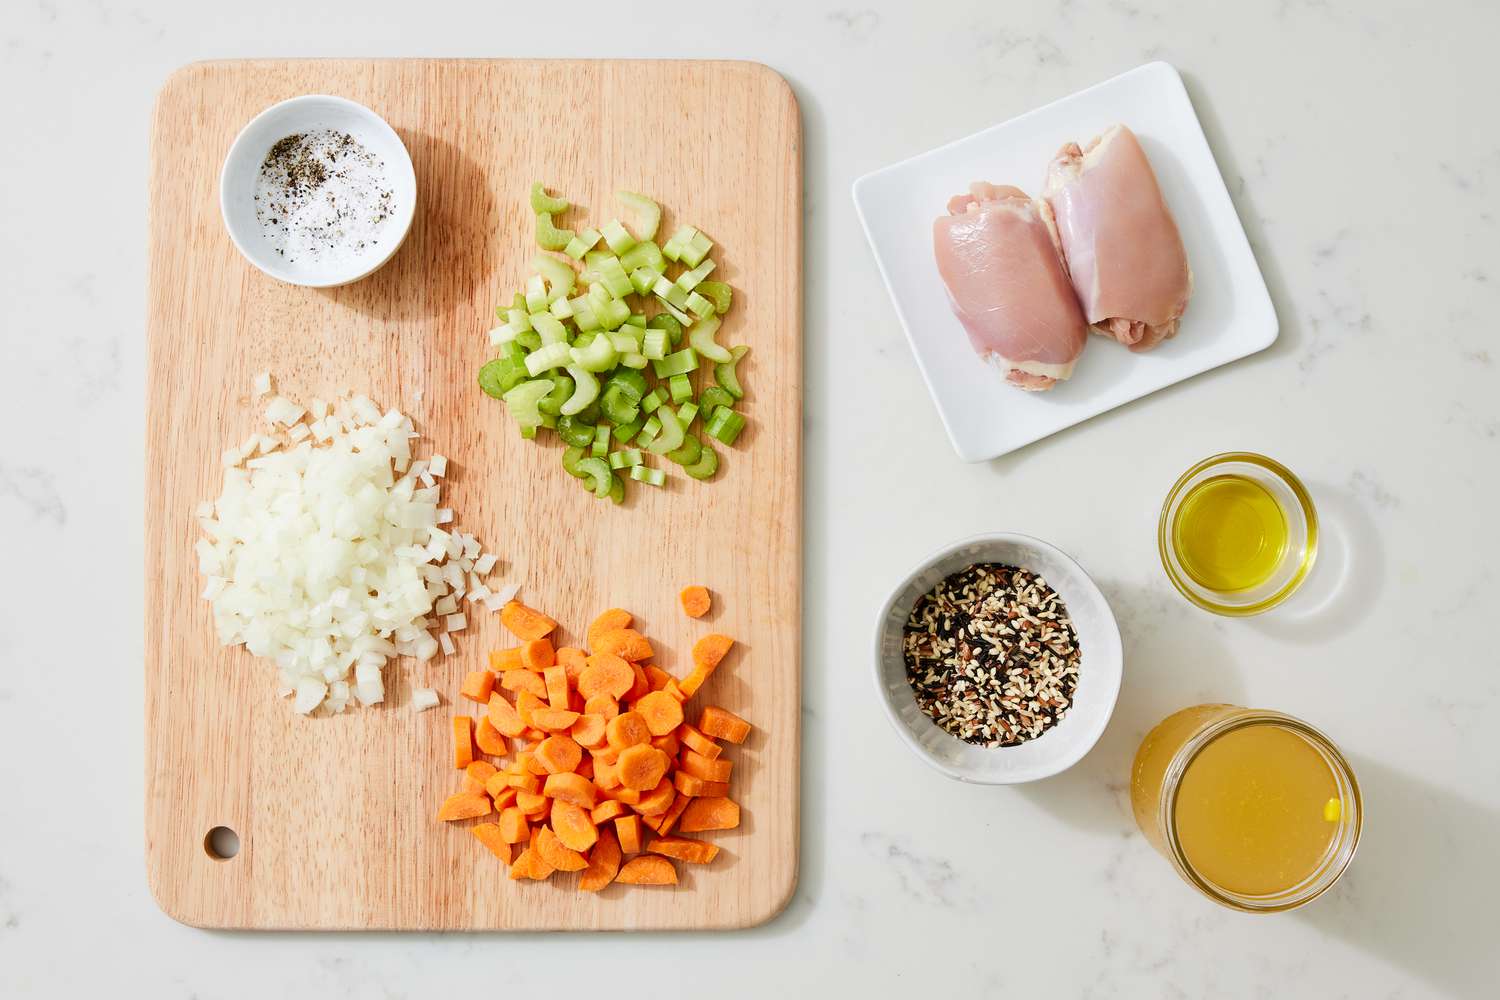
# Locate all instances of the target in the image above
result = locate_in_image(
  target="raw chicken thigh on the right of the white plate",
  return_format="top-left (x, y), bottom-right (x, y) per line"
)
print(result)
top-left (1043, 124), bottom-right (1193, 351)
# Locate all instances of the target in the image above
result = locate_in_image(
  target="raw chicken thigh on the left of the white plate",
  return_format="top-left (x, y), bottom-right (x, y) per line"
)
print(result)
top-left (933, 183), bottom-right (1089, 391)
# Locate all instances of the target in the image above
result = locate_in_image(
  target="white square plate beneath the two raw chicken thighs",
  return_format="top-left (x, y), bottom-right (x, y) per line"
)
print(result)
top-left (854, 63), bottom-right (1278, 462)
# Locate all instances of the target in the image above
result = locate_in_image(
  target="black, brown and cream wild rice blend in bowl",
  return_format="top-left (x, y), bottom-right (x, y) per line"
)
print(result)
top-left (905, 562), bottom-right (1080, 747)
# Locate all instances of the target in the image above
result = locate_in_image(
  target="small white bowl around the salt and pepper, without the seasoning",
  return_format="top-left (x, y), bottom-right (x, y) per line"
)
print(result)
top-left (219, 94), bottom-right (417, 288)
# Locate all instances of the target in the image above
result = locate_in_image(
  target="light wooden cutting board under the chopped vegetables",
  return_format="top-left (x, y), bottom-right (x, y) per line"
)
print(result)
top-left (146, 60), bottom-right (803, 930)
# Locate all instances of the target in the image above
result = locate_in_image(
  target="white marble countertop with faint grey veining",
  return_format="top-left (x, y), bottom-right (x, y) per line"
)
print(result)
top-left (0, 0), bottom-right (1500, 999)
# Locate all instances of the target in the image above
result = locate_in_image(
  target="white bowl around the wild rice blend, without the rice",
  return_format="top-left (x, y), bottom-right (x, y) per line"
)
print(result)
top-left (875, 532), bottom-right (1125, 784)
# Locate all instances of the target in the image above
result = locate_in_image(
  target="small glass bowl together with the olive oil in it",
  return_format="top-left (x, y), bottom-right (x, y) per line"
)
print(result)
top-left (1157, 451), bottom-right (1317, 616)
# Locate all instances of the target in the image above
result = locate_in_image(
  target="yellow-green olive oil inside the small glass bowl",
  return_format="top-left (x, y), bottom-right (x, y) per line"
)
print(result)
top-left (1172, 475), bottom-right (1289, 592)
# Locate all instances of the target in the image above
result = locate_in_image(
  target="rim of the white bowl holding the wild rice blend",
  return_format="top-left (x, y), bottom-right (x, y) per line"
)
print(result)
top-left (872, 531), bottom-right (1125, 786)
